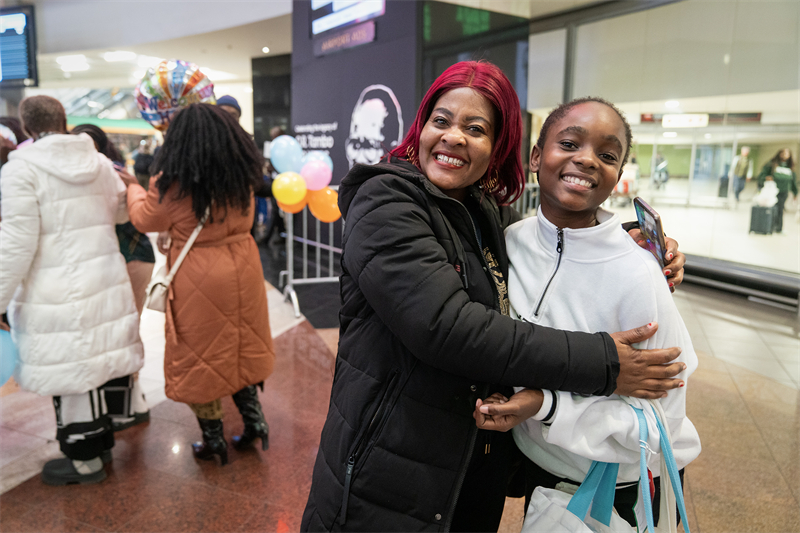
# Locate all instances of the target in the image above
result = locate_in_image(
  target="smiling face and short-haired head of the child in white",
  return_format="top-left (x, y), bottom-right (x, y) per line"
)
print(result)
top-left (531, 102), bottom-right (625, 228)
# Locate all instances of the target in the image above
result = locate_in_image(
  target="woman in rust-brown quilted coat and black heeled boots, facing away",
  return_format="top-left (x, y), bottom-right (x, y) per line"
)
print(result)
top-left (128, 104), bottom-right (275, 465)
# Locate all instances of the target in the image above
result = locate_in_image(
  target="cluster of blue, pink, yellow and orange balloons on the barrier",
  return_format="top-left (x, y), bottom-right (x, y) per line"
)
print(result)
top-left (270, 135), bottom-right (342, 222)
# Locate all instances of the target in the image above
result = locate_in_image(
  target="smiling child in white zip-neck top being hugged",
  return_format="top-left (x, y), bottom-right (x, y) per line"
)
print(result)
top-left (475, 98), bottom-right (700, 525)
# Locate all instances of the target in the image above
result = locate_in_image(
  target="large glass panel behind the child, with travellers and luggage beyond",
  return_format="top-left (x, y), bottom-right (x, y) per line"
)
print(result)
top-left (568, 0), bottom-right (800, 273)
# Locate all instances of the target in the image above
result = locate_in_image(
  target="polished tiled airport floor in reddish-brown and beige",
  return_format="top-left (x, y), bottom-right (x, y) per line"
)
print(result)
top-left (0, 274), bottom-right (800, 533)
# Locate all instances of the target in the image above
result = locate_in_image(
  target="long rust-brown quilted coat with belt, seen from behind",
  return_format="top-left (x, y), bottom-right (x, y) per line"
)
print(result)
top-left (128, 177), bottom-right (275, 403)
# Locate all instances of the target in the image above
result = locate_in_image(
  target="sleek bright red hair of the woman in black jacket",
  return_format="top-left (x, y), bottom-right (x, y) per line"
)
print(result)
top-left (389, 61), bottom-right (525, 205)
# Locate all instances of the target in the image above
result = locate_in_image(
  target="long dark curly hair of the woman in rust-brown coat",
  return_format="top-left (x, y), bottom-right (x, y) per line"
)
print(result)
top-left (151, 104), bottom-right (263, 222)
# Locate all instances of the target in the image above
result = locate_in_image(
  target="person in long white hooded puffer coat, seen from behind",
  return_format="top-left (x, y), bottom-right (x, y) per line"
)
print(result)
top-left (0, 96), bottom-right (144, 485)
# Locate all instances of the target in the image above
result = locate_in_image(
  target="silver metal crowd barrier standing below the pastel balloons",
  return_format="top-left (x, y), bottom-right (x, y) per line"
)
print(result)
top-left (278, 185), bottom-right (344, 318)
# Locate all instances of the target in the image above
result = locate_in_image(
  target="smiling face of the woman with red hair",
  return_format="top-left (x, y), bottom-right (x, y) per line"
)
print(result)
top-left (419, 87), bottom-right (495, 200)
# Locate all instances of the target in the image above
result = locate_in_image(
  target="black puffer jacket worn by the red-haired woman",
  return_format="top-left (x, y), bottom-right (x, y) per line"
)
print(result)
top-left (302, 160), bottom-right (619, 531)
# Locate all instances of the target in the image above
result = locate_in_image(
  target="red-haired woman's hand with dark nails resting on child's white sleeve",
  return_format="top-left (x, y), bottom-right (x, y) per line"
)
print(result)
top-left (611, 322), bottom-right (686, 399)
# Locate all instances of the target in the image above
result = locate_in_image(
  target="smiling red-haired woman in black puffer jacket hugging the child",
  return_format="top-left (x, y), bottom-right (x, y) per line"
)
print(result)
top-left (302, 61), bottom-right (681, 531)
